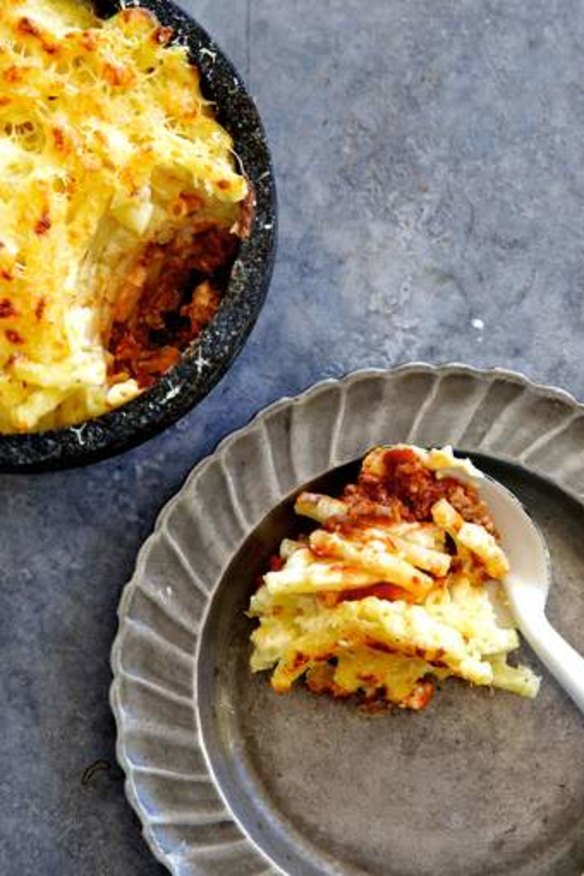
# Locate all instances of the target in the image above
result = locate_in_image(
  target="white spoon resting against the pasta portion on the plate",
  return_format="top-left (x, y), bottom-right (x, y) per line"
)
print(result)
top-left (473, 476), bottom-right (584, 712)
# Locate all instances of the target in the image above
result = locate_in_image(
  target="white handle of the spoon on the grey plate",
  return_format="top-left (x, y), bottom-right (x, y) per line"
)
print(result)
top-left (521, 613), bottom-right (584, 712)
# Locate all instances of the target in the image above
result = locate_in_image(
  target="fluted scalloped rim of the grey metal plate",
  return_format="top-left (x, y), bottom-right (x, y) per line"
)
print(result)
top-left (110, 362), bottom-right (584, 876)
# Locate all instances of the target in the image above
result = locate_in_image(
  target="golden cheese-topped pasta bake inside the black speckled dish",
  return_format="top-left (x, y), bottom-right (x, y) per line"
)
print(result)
top-left (0, 0), bottom-right (252, 432)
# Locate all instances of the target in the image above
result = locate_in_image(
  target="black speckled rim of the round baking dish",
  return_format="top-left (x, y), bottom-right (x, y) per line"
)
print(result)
top-left (0, 0), bottom-right (277, 473)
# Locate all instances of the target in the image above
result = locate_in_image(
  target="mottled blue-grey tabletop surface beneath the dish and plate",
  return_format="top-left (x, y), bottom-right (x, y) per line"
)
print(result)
top-left (0, 0), bottom-right (584, 876)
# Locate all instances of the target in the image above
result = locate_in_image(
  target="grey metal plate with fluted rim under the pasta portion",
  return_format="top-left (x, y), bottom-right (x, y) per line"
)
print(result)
top-left (111, 364), bottom-right (584, 876)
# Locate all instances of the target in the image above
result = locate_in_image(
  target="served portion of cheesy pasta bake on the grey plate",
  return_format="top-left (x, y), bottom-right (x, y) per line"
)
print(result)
top-left (249, 445), bottom-right (539, 709)
